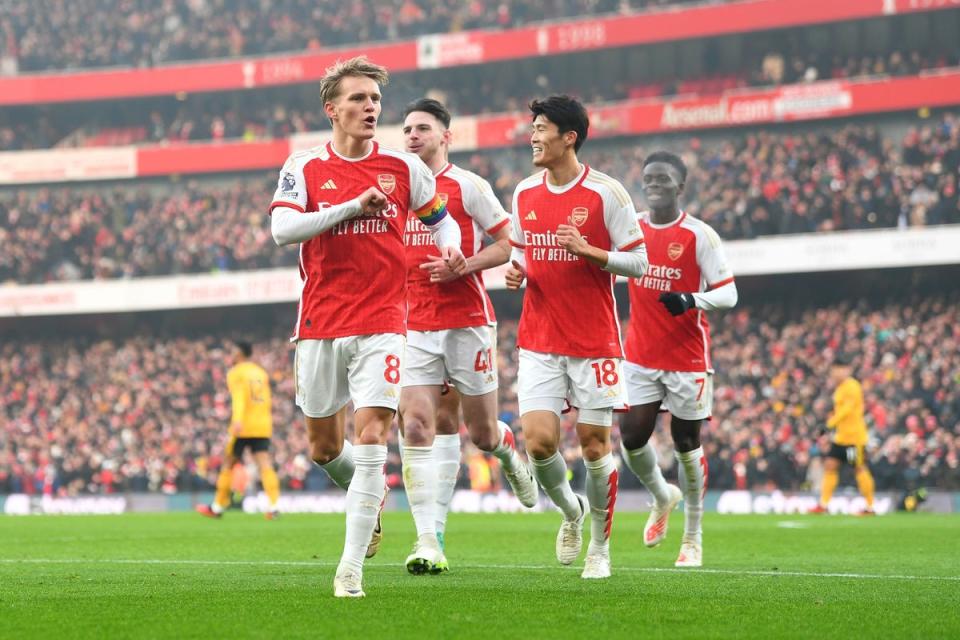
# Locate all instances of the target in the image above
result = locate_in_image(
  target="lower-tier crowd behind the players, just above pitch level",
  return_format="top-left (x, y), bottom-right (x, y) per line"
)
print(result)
top-left (0, 293), bottom-right (960, 495)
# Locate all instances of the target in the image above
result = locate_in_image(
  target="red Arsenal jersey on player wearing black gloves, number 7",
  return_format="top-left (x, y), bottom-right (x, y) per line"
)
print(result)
top-left (626, 213), bottom-right (733, 372)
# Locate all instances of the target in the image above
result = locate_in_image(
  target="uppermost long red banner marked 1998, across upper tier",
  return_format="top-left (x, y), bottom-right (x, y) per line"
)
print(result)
top-left (0, 0), bottom-right (960, 105)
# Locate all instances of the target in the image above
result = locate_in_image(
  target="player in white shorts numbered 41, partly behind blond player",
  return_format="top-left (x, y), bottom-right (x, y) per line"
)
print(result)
top-left (400, 98), bottom-right (537, 573)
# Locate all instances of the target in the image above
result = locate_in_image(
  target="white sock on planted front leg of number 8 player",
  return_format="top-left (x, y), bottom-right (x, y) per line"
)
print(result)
top-left (338, 444), bottom-right (387, 571)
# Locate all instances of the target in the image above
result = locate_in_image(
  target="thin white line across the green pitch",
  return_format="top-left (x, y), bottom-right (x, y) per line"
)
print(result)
top-left (0, 558), bottom-right (960, 582)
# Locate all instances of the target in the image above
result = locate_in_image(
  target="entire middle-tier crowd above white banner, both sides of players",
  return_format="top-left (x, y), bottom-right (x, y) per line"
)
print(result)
top-left (0, 113), bottom-right (960, 284)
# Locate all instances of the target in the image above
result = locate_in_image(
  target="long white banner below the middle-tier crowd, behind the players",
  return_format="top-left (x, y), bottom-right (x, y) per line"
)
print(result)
top-left (0, 225), bottom-right (960, 317)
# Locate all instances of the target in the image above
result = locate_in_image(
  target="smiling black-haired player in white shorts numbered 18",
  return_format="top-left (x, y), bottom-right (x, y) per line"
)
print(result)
top-left (507, 96), bottom-right (647, 578)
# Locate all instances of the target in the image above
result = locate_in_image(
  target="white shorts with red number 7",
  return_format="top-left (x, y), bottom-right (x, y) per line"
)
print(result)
top-left (623, 362), bottom-right (713, 420)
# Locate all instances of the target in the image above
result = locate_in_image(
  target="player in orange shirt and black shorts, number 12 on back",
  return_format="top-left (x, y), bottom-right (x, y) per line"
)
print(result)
top-left (197, 342), bottom-right (280, 520)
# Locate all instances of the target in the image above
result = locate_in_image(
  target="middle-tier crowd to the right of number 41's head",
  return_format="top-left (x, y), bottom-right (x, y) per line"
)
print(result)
top-left (480, 113), bottom-right (960, 240)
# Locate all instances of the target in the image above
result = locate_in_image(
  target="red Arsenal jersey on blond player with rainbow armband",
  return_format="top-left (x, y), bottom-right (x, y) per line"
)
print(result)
top-left (270, 142), bottom-right (445, 340)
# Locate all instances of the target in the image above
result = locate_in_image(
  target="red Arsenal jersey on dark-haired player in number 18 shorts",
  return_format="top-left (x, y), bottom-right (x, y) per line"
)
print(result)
top-left (510, 165), bottom-right (644, 358)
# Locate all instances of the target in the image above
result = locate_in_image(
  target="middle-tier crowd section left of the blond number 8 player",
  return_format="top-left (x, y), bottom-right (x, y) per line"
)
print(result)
top-left (0, 175), bottom-right (282, 283)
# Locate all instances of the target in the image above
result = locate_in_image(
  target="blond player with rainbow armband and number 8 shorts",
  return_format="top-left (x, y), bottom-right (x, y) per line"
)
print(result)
top-left (270, 57), bottom-right (466, 597)
